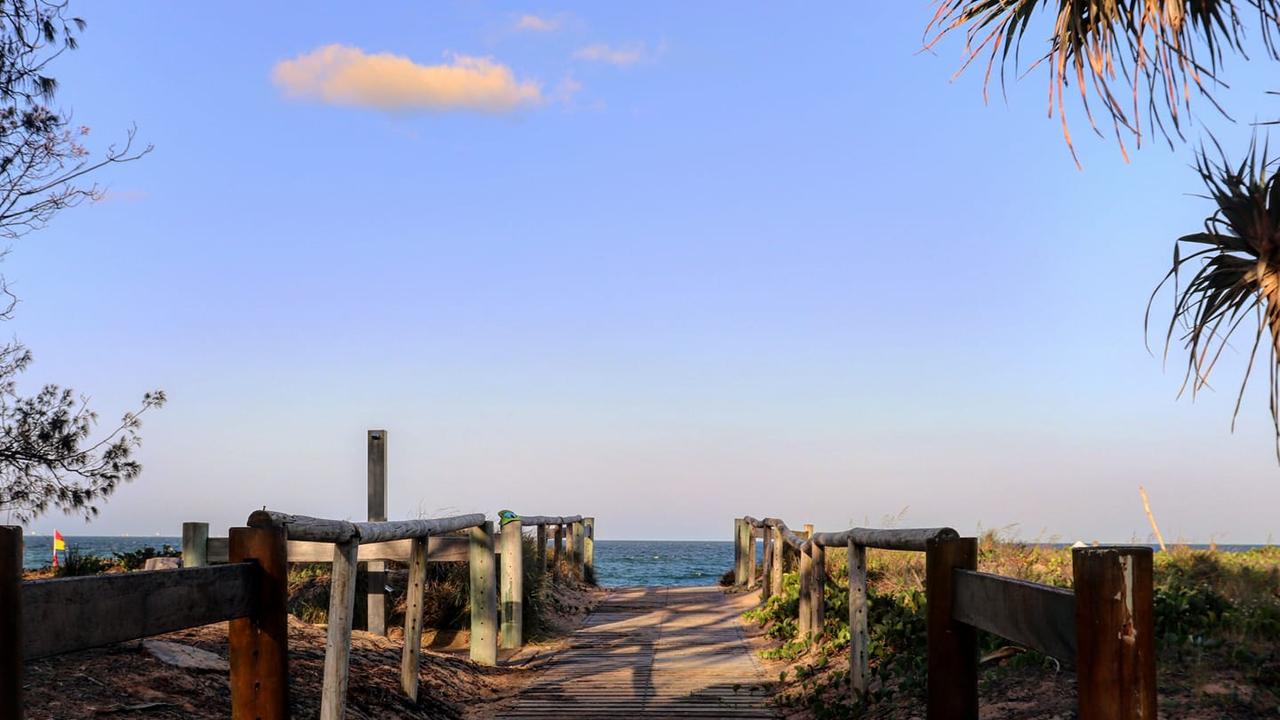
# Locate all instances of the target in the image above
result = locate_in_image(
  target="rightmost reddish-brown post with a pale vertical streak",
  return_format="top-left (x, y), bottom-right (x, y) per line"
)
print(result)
top-left (1071, 546), bottom-right (1156, 720)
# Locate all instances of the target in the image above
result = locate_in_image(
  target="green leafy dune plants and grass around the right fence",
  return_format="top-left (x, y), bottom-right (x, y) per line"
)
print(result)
top-left (746, 534), bottom-right (1280, 720)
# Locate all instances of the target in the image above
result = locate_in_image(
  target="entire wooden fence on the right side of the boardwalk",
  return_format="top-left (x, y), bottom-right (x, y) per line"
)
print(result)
top-left (733, 516), bottom-right (1156, 720)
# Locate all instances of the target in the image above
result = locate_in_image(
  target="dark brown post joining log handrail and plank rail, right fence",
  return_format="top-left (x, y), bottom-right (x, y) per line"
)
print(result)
top-left (924, 538), bottom-right (978, 720)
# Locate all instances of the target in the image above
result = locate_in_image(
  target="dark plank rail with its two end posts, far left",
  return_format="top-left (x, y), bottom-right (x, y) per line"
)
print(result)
top-left (0, 517), bottom-right (288, 720)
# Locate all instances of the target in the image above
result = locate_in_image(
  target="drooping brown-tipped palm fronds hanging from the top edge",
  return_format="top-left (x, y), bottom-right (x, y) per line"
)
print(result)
top-left (925, 0), bottom-right (1280, 164)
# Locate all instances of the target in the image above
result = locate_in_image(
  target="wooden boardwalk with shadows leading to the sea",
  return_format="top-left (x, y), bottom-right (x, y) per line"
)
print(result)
top-left (498, 588), bottom-right (778, 720)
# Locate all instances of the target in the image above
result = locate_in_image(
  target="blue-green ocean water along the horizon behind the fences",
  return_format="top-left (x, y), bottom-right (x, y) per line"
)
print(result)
top-left (23, 536), bottom-right (1261, 588)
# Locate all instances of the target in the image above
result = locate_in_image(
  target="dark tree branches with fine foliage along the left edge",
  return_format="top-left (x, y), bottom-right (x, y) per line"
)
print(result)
top-left (0, 0), bottom-right (165, 521)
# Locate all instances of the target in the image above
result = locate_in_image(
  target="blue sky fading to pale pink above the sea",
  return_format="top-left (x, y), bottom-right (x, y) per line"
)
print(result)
top-left (0, 1), bottom-right (1280, 543)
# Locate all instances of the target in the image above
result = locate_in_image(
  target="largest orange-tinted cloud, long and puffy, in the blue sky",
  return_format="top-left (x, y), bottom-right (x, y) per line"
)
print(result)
top-left (271, 45), bottom-right (543, 113)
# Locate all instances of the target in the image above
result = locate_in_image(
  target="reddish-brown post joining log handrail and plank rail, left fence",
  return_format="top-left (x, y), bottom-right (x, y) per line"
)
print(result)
top-left (227, 520), bottom-right (289, 720)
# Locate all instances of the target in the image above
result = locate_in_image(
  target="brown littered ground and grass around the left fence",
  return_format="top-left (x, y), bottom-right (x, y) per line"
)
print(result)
top-left (26, 535), bottom-right (602, 720)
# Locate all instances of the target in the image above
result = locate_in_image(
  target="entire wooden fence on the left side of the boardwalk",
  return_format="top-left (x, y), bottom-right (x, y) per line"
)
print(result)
top-left (0, 510), bottom-right (595, 720)
